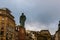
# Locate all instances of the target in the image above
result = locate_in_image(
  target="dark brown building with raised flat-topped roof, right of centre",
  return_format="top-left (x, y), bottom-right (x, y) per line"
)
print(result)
top-left (37, 30), bottom-right (51, 40)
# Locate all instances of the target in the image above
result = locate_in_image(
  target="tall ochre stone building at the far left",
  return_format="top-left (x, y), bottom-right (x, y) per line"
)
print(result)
top-left (0, 8), bottom-right (15, 40)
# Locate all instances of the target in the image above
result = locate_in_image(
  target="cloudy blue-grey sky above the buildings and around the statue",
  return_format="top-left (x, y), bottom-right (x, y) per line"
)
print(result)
top-left (0, 0), bottom-right (60, 34)
